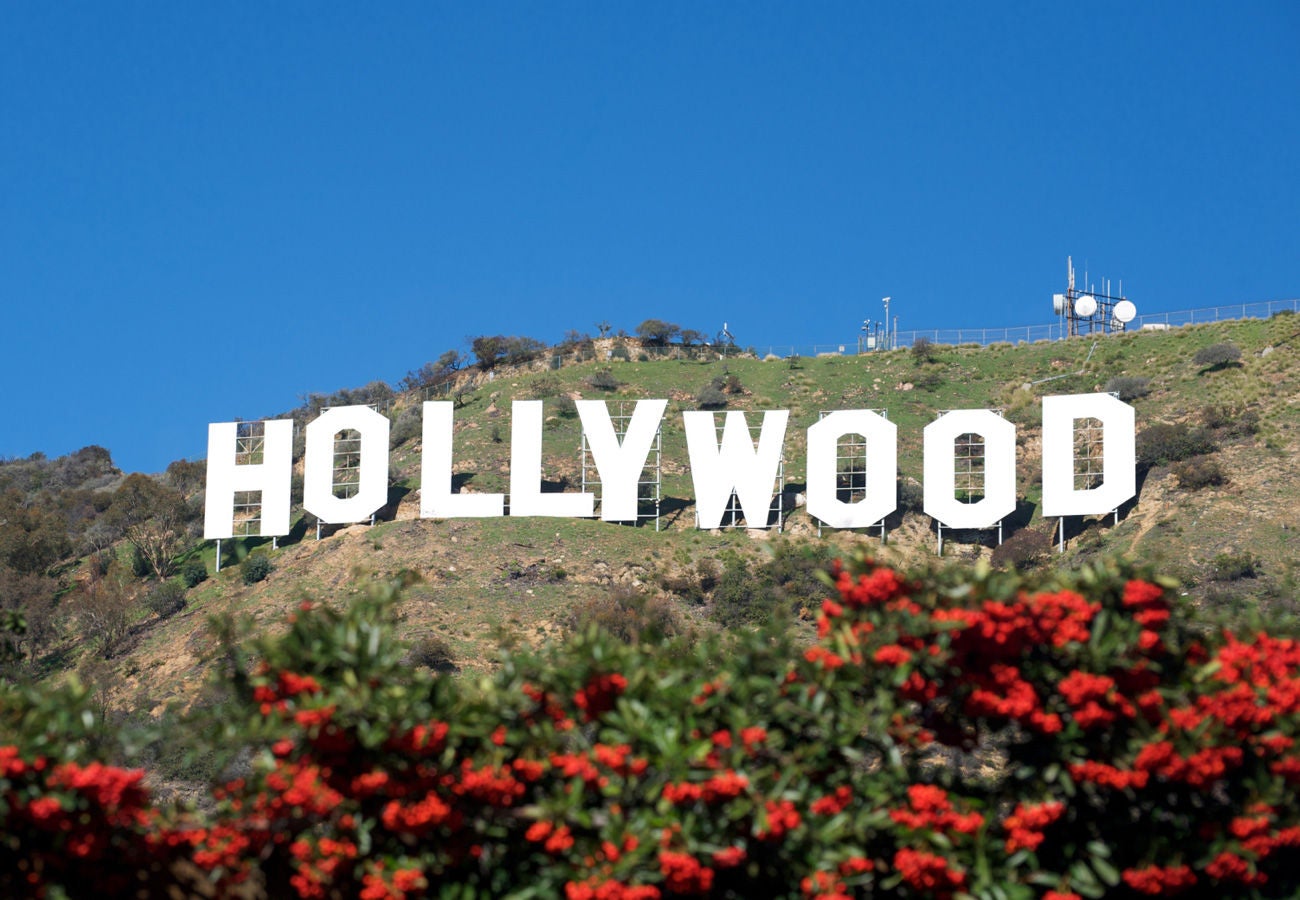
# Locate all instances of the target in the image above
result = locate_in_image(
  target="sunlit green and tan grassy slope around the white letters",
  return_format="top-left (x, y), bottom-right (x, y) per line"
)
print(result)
top-left (55, 316), bottom-right (1300, 713)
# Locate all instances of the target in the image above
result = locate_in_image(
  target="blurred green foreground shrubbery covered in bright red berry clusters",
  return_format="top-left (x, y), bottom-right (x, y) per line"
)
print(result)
top-left (0, 563), bottom-right (1300, 900)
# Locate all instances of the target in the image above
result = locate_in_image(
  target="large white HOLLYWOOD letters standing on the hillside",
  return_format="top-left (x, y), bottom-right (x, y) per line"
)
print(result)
top-left (203, 394), bottom-right (1136, 540)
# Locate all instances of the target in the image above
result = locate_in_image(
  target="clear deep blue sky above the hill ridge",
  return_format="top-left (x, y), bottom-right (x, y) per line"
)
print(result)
top-left (0, 1), bottom-right (1300, 471)
